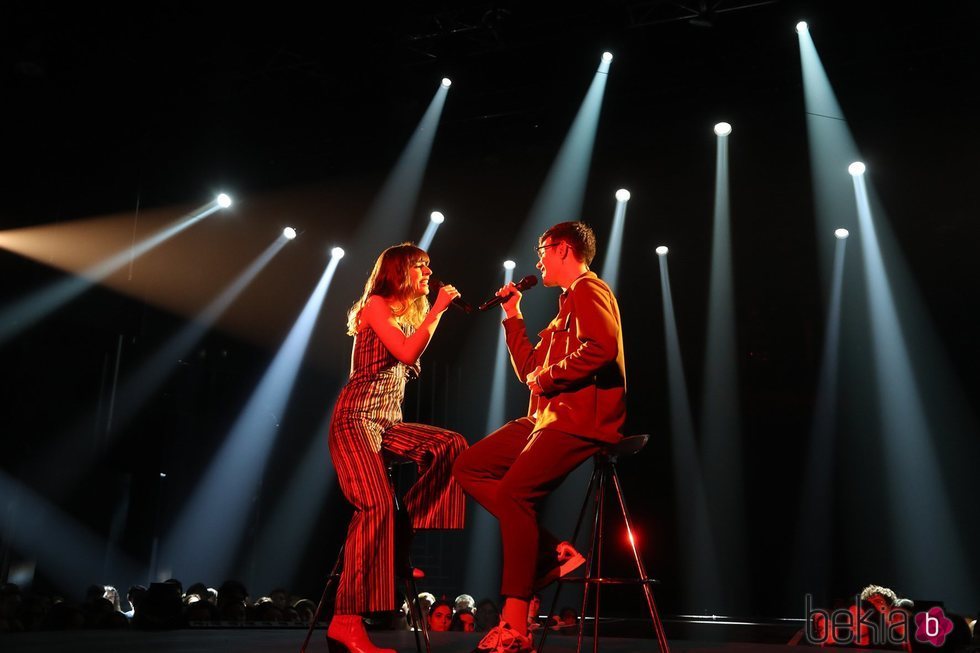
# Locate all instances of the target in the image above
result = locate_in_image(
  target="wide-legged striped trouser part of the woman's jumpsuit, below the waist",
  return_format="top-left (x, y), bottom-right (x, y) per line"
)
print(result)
top-left (328, 415), bottom-right (466, 614)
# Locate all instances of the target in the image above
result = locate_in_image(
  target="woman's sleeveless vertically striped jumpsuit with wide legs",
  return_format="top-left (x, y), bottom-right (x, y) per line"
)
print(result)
top-left (329, 326), bottom-right (466, 614)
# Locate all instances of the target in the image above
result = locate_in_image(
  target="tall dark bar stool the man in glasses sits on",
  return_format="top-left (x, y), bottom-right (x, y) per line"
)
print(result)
top-left (537, 434), bottom-right (670, 653)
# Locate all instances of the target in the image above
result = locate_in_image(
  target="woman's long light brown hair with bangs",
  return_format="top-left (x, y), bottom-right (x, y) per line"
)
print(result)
top-left (347, 243), bottom-right (429, 336)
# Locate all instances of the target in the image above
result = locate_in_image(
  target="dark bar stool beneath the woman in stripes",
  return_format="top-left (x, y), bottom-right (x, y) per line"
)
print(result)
top-left (300, 456), bottom-right (432, 653)
